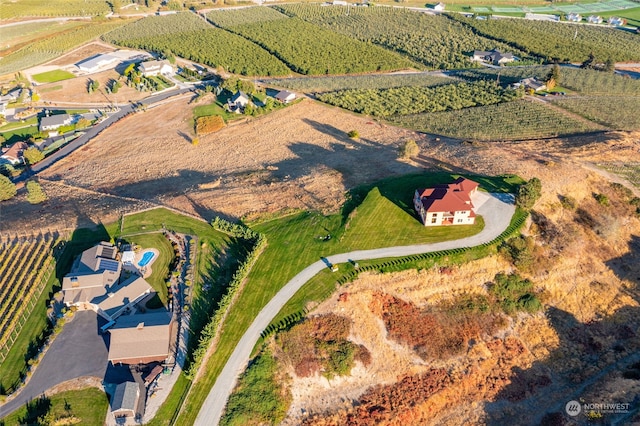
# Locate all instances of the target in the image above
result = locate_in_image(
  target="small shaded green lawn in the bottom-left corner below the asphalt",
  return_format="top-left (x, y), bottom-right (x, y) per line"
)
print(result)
top-left (0, 388), bottom-right (109, 426)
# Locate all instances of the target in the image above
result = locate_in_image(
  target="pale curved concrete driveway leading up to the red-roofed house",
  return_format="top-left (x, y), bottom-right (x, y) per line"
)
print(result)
top-left (195, 192), bottom-right (515, 426)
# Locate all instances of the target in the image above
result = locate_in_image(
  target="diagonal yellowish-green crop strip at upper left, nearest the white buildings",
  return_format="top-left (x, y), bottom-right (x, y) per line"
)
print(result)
top-left (0, 20), bottom-right (127, 75)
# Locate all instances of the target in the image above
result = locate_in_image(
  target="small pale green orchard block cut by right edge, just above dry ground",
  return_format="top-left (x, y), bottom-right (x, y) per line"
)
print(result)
top-left (553, 96), bottom-right (640, 131)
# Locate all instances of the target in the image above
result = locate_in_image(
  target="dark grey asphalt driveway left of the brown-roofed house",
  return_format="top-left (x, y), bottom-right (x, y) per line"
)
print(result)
top-left (0, 311), bottom-right (108, 418)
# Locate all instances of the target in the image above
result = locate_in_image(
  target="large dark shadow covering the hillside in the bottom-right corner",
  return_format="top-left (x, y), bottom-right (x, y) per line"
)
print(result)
top-left (485, 236), bottom-right (640, 425)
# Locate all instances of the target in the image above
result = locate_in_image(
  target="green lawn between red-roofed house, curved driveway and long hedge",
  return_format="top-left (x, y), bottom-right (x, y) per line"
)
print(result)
top-left (172, 173), bottom-right (522, 424)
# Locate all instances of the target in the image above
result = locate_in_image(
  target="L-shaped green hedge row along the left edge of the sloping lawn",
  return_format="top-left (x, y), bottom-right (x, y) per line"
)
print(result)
top-left (185, 217), bottom-right (267, 380)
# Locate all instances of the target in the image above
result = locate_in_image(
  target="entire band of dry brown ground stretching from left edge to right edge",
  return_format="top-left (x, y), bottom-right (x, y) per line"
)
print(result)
top-left (0, 94), bottom-right (638, 235)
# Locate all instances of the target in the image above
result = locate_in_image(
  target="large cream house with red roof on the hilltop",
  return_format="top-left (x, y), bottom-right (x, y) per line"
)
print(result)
top-left (413, 177), bottom-right (478, 226)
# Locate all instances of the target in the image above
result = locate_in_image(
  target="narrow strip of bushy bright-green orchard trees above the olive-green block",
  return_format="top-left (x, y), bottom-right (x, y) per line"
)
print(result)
top-left (318, 81), bottom-right (518, 117)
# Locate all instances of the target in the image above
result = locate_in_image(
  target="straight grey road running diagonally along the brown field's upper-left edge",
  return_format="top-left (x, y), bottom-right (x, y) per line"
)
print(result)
top-left (14, 87), bottom-right (193, 183)
